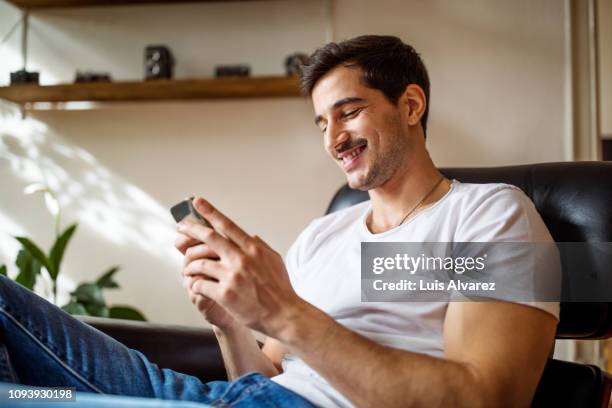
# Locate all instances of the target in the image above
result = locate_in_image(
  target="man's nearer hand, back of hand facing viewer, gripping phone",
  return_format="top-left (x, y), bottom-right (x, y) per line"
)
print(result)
top-left (178, 198), bottom-right (304, 338)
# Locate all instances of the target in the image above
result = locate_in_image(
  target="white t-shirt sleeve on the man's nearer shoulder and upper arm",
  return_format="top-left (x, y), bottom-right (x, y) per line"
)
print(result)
top-left (455, 185), bottom-right (561, 319)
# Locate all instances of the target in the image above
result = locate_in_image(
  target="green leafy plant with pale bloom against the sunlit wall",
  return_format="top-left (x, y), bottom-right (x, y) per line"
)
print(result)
top-left (0, 184), bottom-right (146, 320)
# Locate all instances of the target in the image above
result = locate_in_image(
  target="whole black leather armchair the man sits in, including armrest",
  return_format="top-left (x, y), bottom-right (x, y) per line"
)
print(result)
top-left (84, 162), bottom-right (612, 407)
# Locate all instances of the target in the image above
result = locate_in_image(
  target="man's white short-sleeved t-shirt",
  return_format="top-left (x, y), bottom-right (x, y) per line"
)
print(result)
top-left (272, 180), bottom-right (559, 407)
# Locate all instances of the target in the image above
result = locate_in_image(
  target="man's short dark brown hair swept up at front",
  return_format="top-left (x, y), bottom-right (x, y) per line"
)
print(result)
top-left (302, 35), bottom-right (429, 137)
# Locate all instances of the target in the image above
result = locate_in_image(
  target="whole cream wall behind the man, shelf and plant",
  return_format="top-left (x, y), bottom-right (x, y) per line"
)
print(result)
top-left (0, 0), bottom-right (567, 324)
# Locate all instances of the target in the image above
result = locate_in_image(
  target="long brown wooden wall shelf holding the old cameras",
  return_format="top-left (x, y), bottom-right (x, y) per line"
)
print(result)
top-left (0, 76), bottom-right (300, 104)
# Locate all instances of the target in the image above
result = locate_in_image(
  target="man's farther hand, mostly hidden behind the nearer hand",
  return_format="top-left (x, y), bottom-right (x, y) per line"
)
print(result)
top-left (174, 233), bottom-right (236, 329)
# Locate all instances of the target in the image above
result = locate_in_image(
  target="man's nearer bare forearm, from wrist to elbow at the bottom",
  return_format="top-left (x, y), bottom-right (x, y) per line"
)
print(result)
top-left (279, 305), bottom-right (491, 407)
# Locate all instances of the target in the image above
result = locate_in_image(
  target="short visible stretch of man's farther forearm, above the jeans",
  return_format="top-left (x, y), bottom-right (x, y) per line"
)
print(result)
top-left (213, 325), bottom-right (279, 380)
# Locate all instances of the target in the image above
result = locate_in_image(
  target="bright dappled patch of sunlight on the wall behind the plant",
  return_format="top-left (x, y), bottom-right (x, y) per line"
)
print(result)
top-left (0, 102), bottom-right (197, 323)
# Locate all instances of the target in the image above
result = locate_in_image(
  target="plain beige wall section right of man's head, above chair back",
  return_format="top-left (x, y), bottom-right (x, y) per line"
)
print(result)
top-left (336, 0), bottom-right (566, 166)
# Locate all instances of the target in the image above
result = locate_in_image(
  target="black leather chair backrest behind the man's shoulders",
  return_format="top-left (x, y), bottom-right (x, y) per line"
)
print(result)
top-left (327, 162), bottom-right (612, 339)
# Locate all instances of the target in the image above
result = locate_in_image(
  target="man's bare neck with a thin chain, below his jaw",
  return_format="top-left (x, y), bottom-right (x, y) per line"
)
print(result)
top-left (367, 156), bottom-right (451, 234)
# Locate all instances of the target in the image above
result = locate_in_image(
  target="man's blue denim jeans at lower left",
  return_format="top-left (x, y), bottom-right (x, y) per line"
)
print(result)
top-left (0, 275), bottom-right (313, 408)
